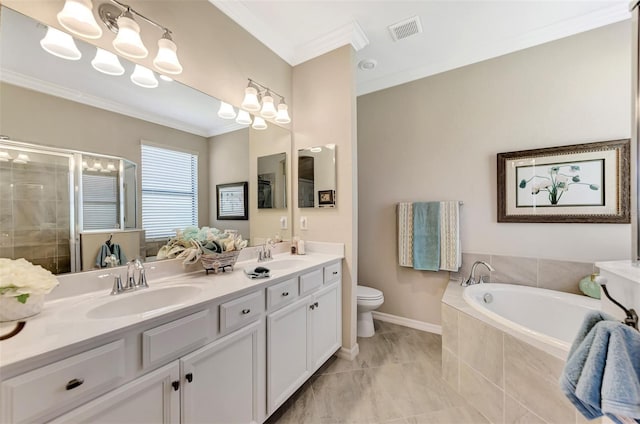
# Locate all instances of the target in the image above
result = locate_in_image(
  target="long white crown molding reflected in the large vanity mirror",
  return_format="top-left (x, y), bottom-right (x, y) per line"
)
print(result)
top-left (0, 68), bottom-right (214, 137)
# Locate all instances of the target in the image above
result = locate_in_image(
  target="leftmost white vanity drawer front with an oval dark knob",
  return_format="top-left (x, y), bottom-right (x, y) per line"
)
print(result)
top-left (1, 340), bottom-right (125, 423)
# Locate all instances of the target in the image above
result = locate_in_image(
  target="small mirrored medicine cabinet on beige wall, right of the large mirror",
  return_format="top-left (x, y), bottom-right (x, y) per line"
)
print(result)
top-left (298, 144), bottom-right (336, 208)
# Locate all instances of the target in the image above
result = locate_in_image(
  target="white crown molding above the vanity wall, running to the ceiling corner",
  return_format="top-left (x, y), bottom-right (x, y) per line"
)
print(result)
top-left (209, 0), bottom-right (294, 66)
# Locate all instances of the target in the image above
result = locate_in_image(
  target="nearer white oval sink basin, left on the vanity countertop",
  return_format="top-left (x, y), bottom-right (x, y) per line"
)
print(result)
top-left (87, 286), bottom-right (202, 319)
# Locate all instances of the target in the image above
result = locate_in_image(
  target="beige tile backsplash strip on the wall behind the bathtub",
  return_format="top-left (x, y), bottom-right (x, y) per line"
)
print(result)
top-left (451, 253), bottom-right (598, 294)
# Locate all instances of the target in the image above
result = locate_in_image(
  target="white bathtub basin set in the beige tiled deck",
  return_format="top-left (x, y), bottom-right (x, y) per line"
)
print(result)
top-left (462, 283), bottom-right (600, 357)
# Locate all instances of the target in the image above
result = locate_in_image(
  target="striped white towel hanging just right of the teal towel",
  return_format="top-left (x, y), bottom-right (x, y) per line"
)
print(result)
top-left (440, 200), bottom-right (462, 272)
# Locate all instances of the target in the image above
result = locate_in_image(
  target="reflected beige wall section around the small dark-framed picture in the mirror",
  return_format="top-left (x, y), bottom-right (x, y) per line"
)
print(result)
top-left (209, 128), bottom-right (249, 239)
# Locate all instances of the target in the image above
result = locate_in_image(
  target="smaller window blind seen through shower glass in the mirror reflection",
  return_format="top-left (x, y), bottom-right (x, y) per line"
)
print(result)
top-left (82, 172), bottom-right (120, 230)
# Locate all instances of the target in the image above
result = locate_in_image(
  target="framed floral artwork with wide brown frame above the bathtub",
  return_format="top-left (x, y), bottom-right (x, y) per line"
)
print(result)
top-left (498, 139), bottom-right (631, 224)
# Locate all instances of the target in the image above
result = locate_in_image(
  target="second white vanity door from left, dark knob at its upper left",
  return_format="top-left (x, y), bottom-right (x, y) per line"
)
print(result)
top-left (180, 320), bottom-right (264, 424)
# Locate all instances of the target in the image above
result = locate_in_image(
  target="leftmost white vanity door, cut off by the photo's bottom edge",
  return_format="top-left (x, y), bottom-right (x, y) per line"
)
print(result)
top-left (51, 361), bottom-right (180, 424)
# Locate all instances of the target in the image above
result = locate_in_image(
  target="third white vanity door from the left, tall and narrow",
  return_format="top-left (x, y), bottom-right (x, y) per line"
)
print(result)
top-left (267, 296), bottom-right (311, 414)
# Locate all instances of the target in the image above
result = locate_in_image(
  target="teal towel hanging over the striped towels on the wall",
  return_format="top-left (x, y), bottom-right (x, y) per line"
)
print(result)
top-left (413, 202), bottom-right (440, 271)
